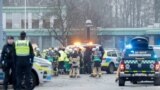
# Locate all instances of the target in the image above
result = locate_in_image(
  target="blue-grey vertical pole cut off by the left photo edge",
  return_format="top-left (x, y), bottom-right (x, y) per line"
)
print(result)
top-left (0, 0), bottom-right (3, 50)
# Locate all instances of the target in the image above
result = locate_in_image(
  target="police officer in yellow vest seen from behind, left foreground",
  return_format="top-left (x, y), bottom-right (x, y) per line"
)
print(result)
top-left (15, 31), bottom-right (34, 90)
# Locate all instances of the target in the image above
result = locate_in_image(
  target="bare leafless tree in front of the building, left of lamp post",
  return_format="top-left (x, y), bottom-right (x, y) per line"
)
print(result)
top-left (43, 0), bottom-right (86, 46)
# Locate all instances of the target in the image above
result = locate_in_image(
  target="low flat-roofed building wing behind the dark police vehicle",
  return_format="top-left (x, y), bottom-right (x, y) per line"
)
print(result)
top-left (98, 28), bottom-right (160, 50)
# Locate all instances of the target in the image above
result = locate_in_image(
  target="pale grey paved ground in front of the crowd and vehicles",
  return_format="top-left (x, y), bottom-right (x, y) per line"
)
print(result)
top-left (35, 74), bottom-right (160, 90)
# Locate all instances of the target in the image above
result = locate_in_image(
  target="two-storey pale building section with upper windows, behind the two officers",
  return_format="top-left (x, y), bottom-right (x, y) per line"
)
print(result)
top-left (3, 7), bottom-right (59, 49)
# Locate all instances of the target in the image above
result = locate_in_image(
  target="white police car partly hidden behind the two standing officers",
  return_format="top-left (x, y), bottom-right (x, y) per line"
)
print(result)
top-left (0, 51), bottom-right (53, 88)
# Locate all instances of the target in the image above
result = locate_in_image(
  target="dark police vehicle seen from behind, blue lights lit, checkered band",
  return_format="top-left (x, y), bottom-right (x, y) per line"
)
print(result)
top-left (119, 37), bottom-right (160, 86)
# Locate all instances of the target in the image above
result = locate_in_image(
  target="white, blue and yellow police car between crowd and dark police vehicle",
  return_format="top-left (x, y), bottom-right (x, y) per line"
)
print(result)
top-left (101, 49), bottom-right (122, 74)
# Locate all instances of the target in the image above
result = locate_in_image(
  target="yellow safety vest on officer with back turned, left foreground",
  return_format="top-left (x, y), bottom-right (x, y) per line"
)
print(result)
top-left (15, 40), bottom-right (30, 56)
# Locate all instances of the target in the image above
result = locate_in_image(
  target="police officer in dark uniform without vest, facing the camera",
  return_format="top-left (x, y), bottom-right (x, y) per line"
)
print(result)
top-left (1, 36), bottom-right (15, 90)
